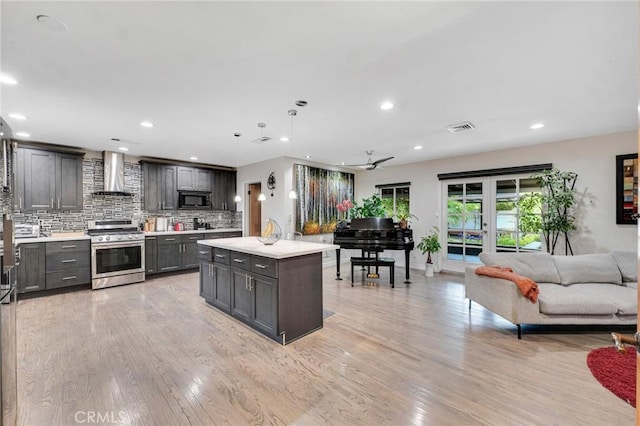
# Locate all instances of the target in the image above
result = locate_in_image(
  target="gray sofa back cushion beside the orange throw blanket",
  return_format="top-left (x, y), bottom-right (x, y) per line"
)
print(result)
top-left (480, 252), bottom-right (560, 284)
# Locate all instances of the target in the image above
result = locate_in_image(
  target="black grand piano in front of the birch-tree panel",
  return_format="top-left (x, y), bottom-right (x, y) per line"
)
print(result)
top-left (333, 217), bottom-right (414, 282)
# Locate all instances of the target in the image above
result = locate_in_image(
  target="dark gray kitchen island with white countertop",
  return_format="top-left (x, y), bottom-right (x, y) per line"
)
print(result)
top-left (198, 237), bottom-right (338, 345)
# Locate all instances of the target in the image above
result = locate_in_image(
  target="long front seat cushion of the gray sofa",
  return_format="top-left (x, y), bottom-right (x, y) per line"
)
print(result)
top-left (538, 283), bottom-right (638, 315)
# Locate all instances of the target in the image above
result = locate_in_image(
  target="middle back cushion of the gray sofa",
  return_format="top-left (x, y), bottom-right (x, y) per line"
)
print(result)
top-left (553, 253), bottom-right (622, 285)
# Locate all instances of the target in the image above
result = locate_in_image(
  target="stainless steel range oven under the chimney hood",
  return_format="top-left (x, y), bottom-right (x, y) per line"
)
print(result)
top-left (88, 220), bottom-right (145, 289)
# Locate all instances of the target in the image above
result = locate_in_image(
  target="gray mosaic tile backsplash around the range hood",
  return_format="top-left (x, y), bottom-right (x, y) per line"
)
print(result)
top-left (14, 158), bottom-right (242, 235)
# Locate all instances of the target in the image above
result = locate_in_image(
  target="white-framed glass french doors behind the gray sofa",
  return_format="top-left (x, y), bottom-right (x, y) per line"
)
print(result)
top-left (440, 175), bottom-right (542, 271)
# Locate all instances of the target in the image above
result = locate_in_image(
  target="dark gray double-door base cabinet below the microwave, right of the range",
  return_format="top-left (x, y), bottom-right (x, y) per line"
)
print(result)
top-left (157, 234), bottom-right (202, 272)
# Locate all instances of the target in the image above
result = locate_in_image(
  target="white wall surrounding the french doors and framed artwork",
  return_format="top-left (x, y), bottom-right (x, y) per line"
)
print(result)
top-left (356, 131), bottom-right (638, 268)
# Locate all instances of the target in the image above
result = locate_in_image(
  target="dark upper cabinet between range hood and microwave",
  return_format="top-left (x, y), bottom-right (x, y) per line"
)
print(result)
top-left (142, 162), bottom-right (178, 212)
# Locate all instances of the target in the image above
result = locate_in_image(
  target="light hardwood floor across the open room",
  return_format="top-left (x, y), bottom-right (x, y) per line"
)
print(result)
top-left (17, 268), bottom-right (634, 426)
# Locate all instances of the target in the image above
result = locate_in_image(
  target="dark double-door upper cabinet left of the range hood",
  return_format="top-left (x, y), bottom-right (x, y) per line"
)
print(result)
top-left (15, 148), bottom-right (82, 210)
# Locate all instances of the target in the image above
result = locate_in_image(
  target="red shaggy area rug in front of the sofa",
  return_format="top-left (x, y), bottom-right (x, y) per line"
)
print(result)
top-left (587, 346), bottom-right (636, 407)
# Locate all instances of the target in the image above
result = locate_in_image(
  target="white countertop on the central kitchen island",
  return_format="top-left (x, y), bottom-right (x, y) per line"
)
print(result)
top-left (198, 237), bottom-right (340, 259)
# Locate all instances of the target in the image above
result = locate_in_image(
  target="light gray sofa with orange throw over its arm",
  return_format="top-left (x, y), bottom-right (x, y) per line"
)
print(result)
top-left (465, 251), bottom-right (638, 339)
